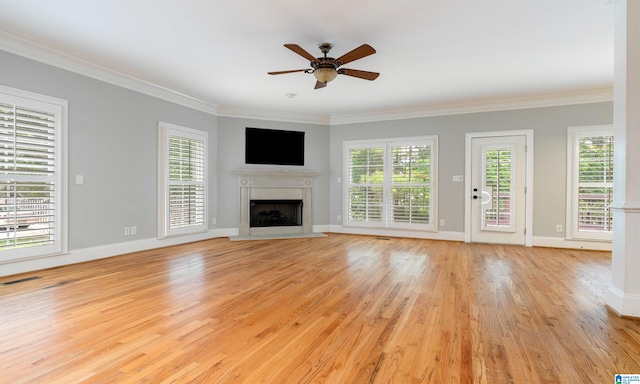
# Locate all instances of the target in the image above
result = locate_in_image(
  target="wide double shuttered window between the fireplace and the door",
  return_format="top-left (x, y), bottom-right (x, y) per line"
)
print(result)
top-left (344, 137), bottom-right (437, 230)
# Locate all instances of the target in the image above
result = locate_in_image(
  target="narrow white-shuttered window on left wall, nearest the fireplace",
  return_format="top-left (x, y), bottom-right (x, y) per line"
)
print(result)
top-left (158, 122), bottom-right (208, 238)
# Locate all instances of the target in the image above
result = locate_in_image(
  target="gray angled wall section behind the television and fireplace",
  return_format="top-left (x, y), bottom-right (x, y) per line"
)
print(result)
top-left (217, 117), bottom-right (330, 228)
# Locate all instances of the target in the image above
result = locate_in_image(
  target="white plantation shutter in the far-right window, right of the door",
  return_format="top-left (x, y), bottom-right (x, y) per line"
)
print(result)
top-left (576, 136), bottom-right (613, 232)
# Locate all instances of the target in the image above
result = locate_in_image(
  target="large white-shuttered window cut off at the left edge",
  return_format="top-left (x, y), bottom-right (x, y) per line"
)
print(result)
top-left (0, 86), bottom-right (67, 260)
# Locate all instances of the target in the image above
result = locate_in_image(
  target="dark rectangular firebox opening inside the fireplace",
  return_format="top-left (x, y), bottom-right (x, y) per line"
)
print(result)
top-left (249, 200), bottom-right (302, 227)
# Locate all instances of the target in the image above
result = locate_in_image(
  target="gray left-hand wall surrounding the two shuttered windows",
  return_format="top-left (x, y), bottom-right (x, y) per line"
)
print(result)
top-left (0, 51), bottom-right (217, 250)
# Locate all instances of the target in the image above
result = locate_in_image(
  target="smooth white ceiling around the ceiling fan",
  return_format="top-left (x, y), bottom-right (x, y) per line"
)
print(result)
top-left (0, 0), bottom-right (615, 120)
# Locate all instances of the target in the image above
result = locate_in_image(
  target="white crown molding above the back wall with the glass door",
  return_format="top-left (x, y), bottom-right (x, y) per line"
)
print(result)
top-left (330, 87), bottom-right (613, 126)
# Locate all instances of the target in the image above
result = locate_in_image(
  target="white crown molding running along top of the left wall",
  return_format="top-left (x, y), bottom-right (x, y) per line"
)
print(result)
top-left (0, 28), bottom-right (218, 115)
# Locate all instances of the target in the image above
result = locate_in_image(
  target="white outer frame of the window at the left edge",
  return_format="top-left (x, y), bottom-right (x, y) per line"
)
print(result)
top-left (0, 85), bottom-right (69, 264)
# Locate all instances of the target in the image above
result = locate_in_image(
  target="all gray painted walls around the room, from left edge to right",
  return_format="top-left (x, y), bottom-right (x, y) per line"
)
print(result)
top-left (0, 47), bottom-right (613, 250)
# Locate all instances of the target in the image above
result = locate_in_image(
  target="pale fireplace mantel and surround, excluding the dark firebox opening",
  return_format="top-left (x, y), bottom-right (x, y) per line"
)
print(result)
top-left (233, 169), bottom-right (319, 236)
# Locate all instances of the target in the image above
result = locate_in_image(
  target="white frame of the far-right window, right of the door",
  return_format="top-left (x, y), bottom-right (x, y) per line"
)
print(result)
top-left (565, 125), bottom-right (613, 241)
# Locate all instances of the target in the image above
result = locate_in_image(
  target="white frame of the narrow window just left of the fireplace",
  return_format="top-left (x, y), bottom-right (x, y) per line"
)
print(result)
top-left (158, 121), bottom-right (209, 239)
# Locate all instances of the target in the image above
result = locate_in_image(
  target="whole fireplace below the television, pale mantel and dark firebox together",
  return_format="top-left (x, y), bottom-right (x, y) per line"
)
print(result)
top-left (233, 169), bottom-right (319, 236)
